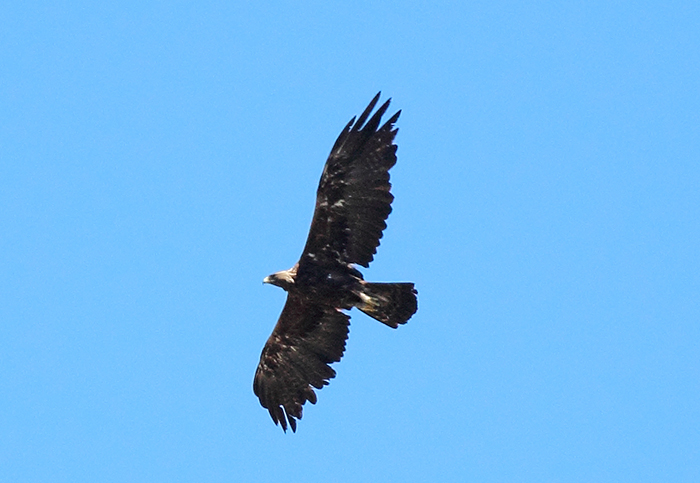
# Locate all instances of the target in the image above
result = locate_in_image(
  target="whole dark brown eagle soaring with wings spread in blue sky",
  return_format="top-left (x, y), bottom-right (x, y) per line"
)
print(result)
top-left (253, 94), bottom-right (418, 432)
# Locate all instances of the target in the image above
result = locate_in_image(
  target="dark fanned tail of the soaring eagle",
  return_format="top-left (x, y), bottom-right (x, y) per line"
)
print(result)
top-left (356, 282), bottom-right (418, 329)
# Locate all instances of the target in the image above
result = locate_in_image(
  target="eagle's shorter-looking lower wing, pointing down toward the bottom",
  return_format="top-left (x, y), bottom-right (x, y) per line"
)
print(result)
top-left (253, 294), bottom-right (350, 432)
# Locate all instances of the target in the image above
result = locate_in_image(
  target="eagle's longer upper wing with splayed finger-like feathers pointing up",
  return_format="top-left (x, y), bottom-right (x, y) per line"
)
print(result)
top-left (299, 93), bottom-right (401, 270)
